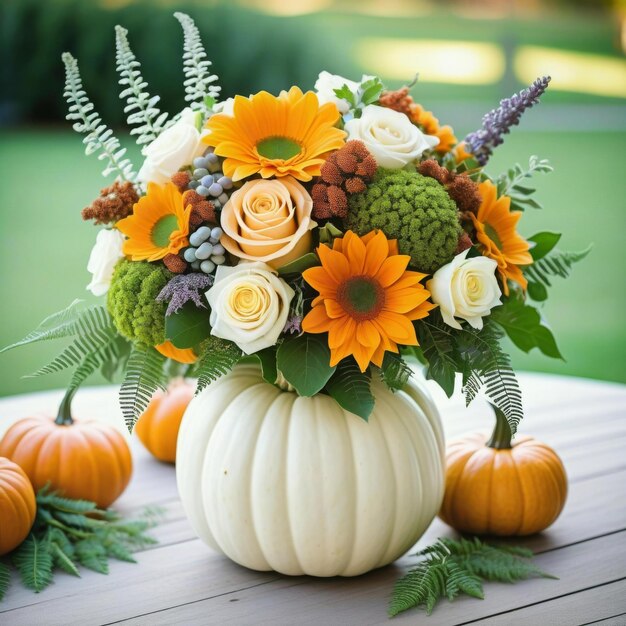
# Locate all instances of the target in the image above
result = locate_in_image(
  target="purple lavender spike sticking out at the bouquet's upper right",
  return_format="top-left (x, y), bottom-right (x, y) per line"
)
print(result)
top-left (465, 76), bottom-right (551, 165)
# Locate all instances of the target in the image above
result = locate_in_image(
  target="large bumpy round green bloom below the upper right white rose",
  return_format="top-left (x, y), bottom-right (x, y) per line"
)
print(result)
top-left (344, 168), bottom-right (461, 274)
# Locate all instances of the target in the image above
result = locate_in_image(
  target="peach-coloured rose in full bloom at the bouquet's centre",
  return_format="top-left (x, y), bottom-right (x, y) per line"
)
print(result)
top-left (220, 176), bottom-right (317, 268)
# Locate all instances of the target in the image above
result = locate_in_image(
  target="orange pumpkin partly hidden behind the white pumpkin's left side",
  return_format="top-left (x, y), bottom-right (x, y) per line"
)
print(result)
top-left (135, 381), bottom-right (195, 463)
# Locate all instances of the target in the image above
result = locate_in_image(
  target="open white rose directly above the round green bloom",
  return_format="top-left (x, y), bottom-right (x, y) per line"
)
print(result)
top-left (345, 104), bottom-right (439, 169)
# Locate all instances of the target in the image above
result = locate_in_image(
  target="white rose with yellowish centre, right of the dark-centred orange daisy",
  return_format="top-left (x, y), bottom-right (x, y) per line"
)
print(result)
top-left (426, 250), bottom-right (502, 330)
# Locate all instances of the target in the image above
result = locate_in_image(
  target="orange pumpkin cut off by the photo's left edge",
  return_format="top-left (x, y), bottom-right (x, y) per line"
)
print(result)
top-left (0, 457), bottom-right (37, 556)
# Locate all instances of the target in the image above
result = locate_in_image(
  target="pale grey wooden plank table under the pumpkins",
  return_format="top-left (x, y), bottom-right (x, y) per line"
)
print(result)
top-left (0, 374), bottom-right (626, 626)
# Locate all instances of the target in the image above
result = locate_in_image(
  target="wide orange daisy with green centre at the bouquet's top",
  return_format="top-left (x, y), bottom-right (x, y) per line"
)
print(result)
top-left (203, 87), bottom-right (346, 181)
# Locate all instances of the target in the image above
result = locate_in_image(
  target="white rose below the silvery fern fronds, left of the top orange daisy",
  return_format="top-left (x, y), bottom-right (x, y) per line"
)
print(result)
top-left (137, 109), bottom-right (206, 185)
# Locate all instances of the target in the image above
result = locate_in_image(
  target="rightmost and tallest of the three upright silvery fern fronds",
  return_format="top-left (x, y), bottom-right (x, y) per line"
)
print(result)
top-left (174, 13), bottom-right (221, 114)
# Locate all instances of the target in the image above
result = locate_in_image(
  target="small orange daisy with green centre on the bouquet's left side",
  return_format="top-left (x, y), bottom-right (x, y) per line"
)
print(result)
top-left (115, 183), bottom-right (192, 261)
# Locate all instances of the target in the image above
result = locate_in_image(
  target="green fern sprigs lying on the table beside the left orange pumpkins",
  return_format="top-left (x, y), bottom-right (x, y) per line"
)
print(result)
top-left (0, 487), bottom-right (159, 600)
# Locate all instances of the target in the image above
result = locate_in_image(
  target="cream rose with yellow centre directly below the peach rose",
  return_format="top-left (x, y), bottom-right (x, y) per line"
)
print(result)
top-left (205, 262), bottom-right (294, 354)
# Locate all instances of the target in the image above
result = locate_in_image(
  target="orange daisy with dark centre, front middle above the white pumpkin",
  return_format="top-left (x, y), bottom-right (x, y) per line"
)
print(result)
top-left (302, 231), bottom-right (434, 372)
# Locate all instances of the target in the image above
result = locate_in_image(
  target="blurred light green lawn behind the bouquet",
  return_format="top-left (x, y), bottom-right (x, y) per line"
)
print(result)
top-left (0, 129), bottom-right (626, 395)
